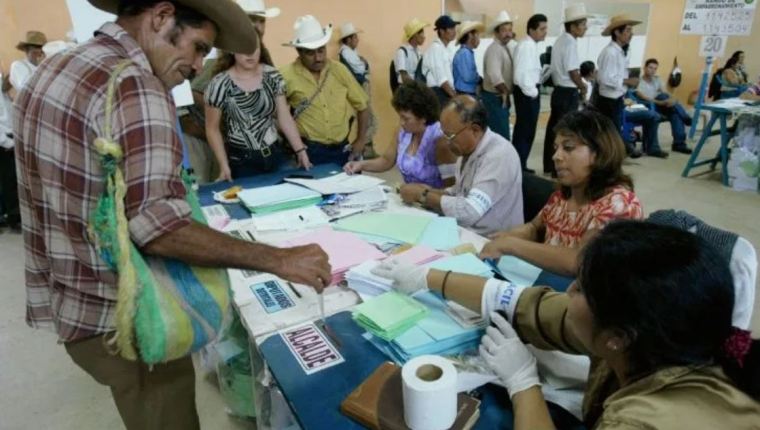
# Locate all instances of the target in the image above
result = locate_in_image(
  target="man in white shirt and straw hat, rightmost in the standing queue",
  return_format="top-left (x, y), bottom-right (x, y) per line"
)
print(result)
top-left (595, 15), bottom-right (641, 158)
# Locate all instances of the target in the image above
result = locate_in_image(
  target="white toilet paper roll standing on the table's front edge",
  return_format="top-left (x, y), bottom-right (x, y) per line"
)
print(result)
top-left (401, 355), bottom-right (457, 430)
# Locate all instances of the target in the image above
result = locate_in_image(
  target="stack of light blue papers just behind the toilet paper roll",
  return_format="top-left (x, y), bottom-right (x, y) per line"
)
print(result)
top-left (369, 292), bottom-right (484, 364)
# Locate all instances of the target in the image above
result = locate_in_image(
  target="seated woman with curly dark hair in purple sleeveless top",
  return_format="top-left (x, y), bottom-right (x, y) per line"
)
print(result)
top-left (343, 81), bottom-right (456, 188)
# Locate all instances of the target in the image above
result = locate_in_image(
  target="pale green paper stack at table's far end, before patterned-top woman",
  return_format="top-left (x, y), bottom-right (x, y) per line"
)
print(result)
top-left (238, 184), bottom-right (322, 214)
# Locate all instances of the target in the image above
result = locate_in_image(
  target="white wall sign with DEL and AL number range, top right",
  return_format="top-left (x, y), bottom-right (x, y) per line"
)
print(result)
top-left (681, 0), bottom-right (760, 36)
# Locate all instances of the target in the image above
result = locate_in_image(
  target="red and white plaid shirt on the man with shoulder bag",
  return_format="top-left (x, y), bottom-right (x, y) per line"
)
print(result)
top-left (14, 23), bottom-right (190, 342)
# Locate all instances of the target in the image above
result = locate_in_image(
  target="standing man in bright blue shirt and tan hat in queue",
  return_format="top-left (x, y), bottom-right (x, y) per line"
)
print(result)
top-left (452, 21), bottom-right (485, 96)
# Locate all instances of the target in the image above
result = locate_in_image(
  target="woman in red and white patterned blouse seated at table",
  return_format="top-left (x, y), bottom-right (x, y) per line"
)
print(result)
top-left (480, 110), bottom-right (643, 276)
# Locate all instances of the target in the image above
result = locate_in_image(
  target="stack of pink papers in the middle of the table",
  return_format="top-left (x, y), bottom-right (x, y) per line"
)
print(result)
top-left (278, 227), bottom-right (385, 285)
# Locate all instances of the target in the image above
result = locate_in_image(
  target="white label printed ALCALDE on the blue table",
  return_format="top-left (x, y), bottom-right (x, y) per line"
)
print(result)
top-left (280, 323), bottom-right (345, 375)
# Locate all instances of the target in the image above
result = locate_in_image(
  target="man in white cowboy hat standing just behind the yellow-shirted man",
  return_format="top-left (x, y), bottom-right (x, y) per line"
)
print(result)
top-left (338, 22), bottom-right (377, 158)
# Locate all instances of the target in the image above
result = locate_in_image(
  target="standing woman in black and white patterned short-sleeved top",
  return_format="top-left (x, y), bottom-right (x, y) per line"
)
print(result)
top-left (205, 41), bottom-right (311, 180)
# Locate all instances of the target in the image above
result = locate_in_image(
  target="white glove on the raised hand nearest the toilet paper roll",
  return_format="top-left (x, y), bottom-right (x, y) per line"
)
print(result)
top-left (480, 312), bottom-right (541, 398)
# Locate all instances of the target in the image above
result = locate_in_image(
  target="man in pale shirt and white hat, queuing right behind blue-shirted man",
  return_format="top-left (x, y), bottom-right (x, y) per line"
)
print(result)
top-left (480, 10), bottom-right (514, 140)
